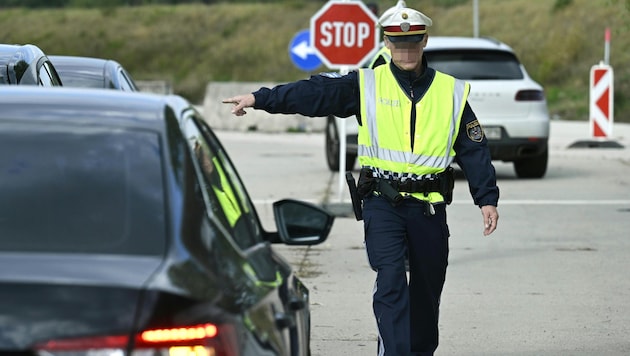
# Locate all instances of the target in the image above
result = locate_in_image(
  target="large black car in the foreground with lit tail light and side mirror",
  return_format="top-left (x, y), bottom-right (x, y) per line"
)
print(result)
top-left (0, 86), bottom-right (334, 356)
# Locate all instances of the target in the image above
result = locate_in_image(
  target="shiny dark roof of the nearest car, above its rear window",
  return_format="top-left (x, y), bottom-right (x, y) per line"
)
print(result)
top-left (0, 85), bottom-right (193, 132)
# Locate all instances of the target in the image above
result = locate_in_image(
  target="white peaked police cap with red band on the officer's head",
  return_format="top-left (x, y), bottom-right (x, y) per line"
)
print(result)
top-left (379, 7), bottom-right (433, 42)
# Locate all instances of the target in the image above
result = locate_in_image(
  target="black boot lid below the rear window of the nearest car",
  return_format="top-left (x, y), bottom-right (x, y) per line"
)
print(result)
top-left (0, 253), bottom-right (162, 351)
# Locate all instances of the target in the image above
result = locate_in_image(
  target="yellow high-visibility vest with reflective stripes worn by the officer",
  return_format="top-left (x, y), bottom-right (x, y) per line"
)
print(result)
top-left (358, 66), bottom-right (470, 203)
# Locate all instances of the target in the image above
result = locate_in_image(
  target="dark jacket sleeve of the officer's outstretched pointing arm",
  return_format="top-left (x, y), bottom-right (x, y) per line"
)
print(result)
top-left (253, 71), bottom-right (359, 117)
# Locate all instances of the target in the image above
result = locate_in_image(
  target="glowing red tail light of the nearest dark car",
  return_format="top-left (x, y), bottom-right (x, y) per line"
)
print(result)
top-left (35, 324), bottom-right (238, 356)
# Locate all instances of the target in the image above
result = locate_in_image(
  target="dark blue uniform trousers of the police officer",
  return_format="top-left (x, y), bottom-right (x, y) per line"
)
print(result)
top-left (363, 196), bottom-right (449, 356)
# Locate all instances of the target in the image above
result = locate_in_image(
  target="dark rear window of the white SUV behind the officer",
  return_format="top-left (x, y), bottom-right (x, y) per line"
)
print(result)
top-left (425, 49), bottom-right (523, 80)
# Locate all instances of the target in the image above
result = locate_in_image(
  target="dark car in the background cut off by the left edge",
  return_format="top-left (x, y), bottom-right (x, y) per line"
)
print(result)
top-left (0, 44), bottom-right (62, 87)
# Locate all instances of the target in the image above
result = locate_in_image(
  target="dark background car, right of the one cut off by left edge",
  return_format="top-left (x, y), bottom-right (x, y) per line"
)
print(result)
top-left (48, 55), bottom-right (138, 91)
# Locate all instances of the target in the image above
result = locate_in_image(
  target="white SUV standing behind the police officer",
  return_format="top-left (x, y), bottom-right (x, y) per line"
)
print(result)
top-left (326, 36), bottom-right (549, 178)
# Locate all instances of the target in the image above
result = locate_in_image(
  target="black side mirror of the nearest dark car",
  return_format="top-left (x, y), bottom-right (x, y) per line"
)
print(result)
top-left (273, 199), bottom-right (335, 245)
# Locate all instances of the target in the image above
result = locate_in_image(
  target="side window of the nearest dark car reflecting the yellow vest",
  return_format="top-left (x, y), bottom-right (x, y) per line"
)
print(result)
top-left (186, 117), bottom-right (262, 250)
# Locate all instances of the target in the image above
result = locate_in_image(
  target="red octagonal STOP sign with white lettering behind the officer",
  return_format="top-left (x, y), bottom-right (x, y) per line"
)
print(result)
top-left (310, 1), bottom-right (380, 68)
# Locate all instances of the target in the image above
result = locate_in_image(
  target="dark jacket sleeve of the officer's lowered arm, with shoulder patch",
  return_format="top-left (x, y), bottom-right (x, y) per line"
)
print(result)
top-left (455, 103), bottom-right (499, 206)
